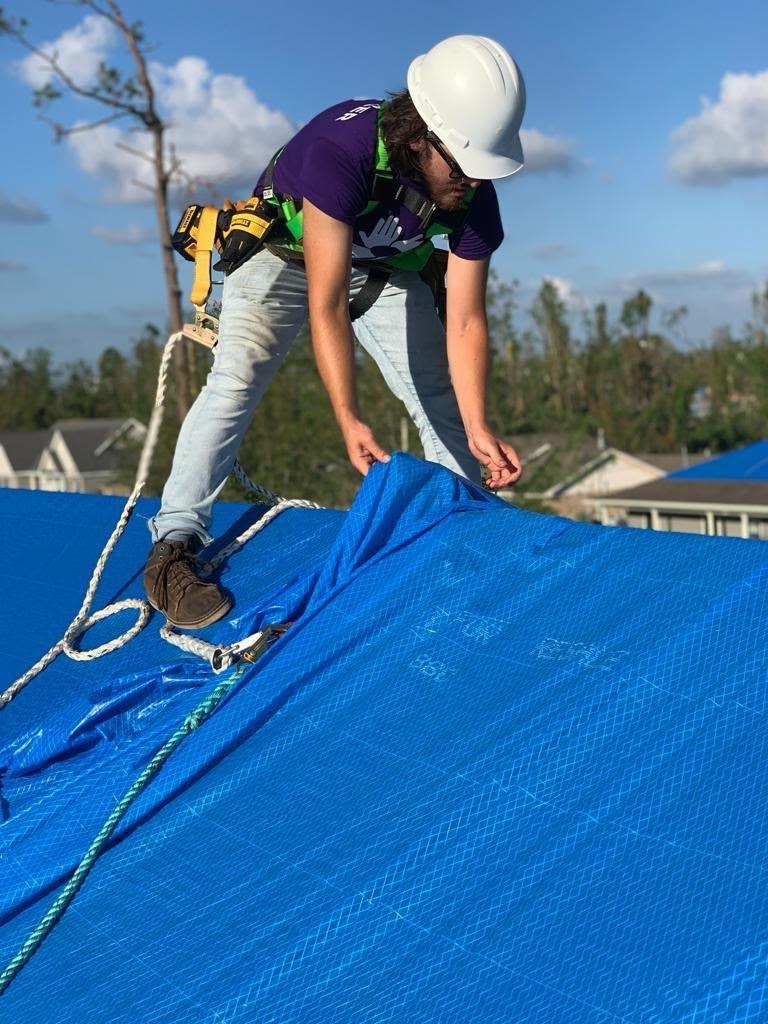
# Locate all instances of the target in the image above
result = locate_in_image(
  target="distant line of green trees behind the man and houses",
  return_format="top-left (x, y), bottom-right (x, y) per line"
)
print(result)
top-left (0, 279), bottom-right (768, 505)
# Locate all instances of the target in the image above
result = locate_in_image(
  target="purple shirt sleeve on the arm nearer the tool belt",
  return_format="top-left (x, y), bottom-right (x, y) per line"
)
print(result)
top-left (302, 137), bottom-right (370, 224)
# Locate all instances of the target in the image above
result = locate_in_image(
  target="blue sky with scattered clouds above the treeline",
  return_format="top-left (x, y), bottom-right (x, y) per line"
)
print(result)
top-left (0, 0), bottom-right (768, 361)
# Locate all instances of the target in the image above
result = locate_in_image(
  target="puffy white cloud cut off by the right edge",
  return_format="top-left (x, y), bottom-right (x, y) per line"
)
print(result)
top-left (669, 71), bottom-right (768, 184)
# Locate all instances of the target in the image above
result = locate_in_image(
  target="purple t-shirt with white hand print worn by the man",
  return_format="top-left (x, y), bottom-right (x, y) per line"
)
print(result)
top-left (254, 99), bottom-right (504, 260)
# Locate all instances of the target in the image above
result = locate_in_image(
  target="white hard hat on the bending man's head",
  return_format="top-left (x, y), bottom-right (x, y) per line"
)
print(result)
top-left (408, 36), bottom-right (525, 178)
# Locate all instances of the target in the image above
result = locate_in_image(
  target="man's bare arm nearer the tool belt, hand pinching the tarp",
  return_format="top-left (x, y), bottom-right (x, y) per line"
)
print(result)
top-left (303, 200), bottom-right (389, 476)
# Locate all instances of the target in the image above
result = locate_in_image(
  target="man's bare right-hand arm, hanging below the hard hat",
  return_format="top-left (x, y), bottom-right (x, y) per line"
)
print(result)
top-left (445, 253), bottom-right (521, 489)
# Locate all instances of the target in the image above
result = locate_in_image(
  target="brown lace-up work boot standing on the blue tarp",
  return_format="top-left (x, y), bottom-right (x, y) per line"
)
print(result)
top-left (144, 539), bottom-right (232, 630)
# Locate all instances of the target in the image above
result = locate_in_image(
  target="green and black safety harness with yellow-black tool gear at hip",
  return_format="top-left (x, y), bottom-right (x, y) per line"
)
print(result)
top-left (172, 103), bottom-right (475, 321)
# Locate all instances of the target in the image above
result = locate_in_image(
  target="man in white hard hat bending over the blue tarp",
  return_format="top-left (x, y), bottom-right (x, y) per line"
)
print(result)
top-left (144, 36), bottom-right (525, 629)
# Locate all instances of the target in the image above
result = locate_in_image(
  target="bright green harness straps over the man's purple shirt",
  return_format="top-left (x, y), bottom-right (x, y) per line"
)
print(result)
top-left (263, 103), bottom-right (475, 270)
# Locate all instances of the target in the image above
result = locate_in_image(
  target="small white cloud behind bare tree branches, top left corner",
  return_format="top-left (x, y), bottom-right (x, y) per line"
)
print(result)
top-left (14, 14), bottom-right (117, 89)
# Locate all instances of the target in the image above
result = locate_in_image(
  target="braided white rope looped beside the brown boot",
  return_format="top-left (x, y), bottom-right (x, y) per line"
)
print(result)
top-left (0, 332), bottom-right (321, 711)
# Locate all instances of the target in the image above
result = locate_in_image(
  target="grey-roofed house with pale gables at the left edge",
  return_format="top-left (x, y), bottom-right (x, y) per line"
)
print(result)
top-left (0, 417), bottom-right (146, 493)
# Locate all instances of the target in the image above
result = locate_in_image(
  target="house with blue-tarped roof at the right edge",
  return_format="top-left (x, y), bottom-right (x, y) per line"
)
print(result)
top-left (593, 440), bottom-right (768, 540)
